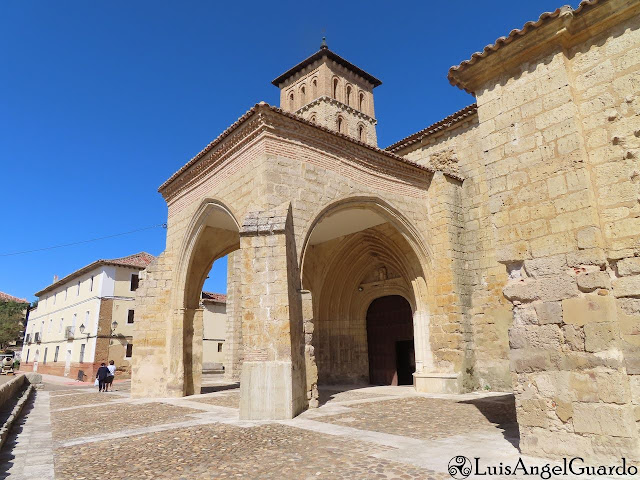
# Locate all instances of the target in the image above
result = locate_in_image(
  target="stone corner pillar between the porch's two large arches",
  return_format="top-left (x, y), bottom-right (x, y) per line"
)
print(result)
top-left (239, 204), bottom-right (306, 420)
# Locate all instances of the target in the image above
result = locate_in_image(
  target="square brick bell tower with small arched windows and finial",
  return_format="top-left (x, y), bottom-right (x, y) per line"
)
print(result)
top-left (271, 38), bottom-right (382, 146)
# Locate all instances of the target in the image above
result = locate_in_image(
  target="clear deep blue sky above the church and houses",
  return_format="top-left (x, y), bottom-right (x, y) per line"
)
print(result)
top-left (0, 0), bottom-right (577, 300)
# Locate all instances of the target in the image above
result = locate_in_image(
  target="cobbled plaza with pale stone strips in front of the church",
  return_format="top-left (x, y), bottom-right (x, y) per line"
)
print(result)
top-left (0, 376), bottom-right (592, 480)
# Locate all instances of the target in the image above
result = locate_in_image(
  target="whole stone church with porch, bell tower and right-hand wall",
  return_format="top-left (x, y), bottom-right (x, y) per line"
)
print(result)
top-left (132, 0), bottom-right (640, 460)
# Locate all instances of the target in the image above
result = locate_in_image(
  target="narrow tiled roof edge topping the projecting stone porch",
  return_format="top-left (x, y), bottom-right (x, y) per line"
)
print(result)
top-left (158, 102), bottom-right (463, 193)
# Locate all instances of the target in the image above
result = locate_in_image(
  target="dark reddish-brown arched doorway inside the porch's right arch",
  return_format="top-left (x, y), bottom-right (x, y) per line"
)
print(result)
top-left (367, 295), bottom-right (416, 385)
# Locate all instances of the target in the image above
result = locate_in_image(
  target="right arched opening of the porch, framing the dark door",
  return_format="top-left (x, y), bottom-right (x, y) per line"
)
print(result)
top-left (301, 199), bottom-right (433, 403)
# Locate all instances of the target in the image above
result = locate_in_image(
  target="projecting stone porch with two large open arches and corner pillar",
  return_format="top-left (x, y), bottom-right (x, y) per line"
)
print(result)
top-left (132, 105), bottom-right (467, 419)
